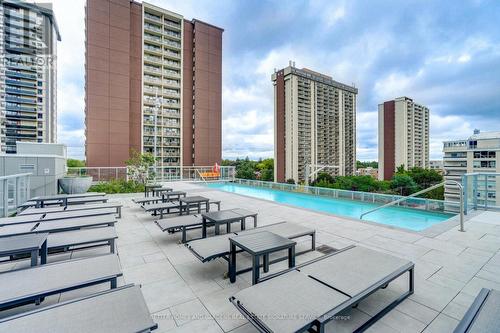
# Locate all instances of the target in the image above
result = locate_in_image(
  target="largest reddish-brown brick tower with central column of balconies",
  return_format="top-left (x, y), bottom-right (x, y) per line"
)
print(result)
top-left (85, 0), bottom-right (223, 176)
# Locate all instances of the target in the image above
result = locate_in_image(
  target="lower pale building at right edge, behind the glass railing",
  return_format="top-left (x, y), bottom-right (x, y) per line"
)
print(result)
top-left (443, 130), bottom-right (500, 206)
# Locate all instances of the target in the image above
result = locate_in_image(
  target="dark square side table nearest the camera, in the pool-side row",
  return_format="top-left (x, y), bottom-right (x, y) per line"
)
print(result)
top-left (229, 231), bottom-right (297, 284)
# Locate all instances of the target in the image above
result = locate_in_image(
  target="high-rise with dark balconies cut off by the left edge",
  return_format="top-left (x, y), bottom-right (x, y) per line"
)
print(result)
top-left (0, 0), bottom-right (61, 153)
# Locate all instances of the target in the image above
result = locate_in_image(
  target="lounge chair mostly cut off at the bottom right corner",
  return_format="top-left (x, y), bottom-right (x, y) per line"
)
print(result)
top-left (453, 288), bottom-right (500, 333)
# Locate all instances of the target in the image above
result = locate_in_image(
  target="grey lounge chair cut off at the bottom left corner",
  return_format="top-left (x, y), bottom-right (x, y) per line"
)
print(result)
top-left (0, 285), bottom-right (158, 333)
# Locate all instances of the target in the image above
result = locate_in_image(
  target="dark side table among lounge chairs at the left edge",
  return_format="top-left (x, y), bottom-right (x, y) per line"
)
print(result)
top-left (0, 233), bottom-right (49, 266)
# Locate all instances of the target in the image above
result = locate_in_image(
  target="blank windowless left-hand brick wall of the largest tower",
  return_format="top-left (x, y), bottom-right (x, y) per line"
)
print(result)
top-left (85, 0), bottom-right (131, 166)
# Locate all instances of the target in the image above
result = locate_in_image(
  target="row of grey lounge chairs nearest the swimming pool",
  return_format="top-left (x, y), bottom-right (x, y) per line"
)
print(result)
top-left (131, 185), bottom-right (500, 333)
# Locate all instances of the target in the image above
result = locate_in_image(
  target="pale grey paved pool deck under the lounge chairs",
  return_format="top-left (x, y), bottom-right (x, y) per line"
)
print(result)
top-left (0, 182), bottom-right (500, 333)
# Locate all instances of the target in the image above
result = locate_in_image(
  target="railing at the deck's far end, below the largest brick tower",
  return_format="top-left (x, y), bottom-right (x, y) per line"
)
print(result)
top-left (68, 166), bottom-right (236, 183)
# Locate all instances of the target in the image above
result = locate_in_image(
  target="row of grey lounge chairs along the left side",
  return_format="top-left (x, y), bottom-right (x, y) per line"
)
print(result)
top-left (0, 194), bottom-right (157, 332)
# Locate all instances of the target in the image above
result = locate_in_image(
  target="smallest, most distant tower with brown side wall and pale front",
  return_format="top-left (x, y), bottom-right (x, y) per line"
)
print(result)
top-left (378, 97), bottom-right (429, 180)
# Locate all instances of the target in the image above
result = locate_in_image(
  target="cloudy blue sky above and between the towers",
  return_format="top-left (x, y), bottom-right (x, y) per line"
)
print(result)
top-left (52, 0), bottom-right (500, 160)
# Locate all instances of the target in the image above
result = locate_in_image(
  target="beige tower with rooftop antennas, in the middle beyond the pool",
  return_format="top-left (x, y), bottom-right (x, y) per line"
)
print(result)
top-left (272, 63), bottom-right (358, 182)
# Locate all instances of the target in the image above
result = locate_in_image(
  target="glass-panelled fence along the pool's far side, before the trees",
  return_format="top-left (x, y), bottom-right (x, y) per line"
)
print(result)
top-left (235, 178), bottom-right (460, 212)
